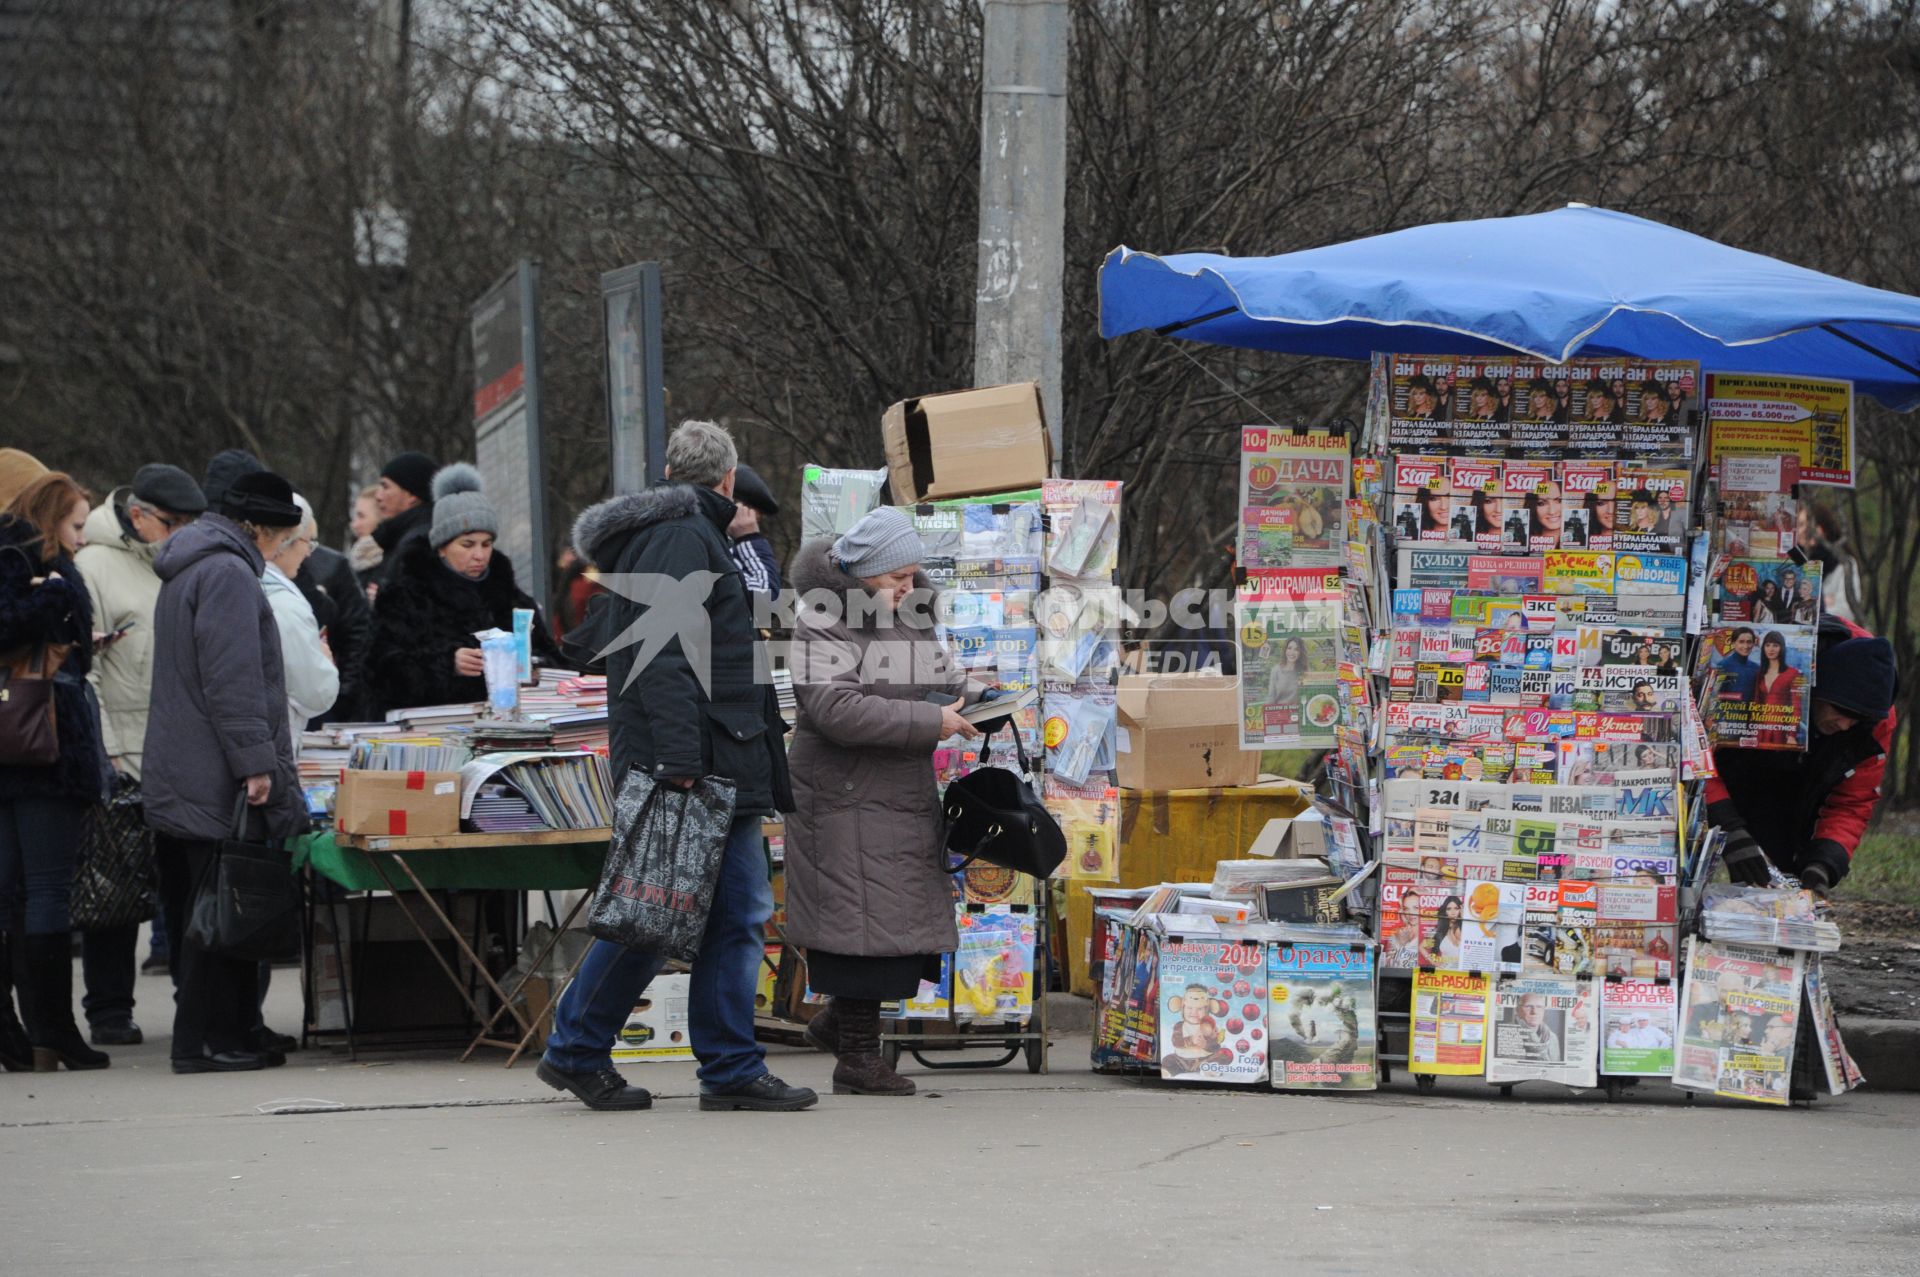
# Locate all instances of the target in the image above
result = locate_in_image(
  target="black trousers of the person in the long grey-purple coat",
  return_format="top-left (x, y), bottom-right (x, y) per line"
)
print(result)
top-left (154, 833), bottom-right (259, 1060)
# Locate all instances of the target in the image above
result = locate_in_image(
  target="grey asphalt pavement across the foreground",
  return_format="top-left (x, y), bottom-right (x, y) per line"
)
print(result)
top-left (0, 960), bottom-right (1920, 1277)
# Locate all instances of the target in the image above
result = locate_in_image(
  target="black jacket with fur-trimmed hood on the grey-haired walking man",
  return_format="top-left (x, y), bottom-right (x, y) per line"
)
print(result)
top-left (568, 482), bottom-right (793, 816)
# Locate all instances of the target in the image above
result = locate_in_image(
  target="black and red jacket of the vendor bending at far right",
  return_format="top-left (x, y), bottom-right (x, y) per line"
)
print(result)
top-left (1707, 618), bottom-right (1897, 883)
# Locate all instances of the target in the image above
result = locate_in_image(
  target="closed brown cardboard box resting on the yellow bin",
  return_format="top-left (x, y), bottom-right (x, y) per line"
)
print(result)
top-left (1117, 674), bottom-right (1260, 789)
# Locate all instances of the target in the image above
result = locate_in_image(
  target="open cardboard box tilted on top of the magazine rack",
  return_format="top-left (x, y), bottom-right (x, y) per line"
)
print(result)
top-left (879, 382), bottom-right (1054, 505)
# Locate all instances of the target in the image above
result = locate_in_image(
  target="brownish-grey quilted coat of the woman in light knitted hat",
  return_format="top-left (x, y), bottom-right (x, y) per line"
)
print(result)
top-left (785, 540), bottom-right (981, 958)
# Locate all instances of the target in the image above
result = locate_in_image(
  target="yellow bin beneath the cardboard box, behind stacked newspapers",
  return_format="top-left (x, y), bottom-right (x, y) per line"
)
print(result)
top-left (1066, 780), bottom-right (1309, 997)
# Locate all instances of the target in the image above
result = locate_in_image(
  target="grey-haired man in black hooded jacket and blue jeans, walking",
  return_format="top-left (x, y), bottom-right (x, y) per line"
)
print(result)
top-left (538, 421), bottom-right (818, 1112)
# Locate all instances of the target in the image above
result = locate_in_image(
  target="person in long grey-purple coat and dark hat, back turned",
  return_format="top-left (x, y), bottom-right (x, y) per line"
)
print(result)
top-left (142, 470), bottom-right (307, 1073)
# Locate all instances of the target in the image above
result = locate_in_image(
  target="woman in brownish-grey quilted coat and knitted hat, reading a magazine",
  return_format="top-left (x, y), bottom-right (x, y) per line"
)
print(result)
top-left (785, 507), bottom-right (979, 1095)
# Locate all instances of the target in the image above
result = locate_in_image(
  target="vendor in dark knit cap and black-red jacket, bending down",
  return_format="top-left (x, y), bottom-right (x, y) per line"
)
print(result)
top-left (1707, 616), bottom-right (1897, 893)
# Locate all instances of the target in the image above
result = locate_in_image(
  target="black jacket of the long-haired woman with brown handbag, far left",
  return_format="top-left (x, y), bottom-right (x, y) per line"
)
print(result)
top-left (0, 515), bottom-right (108, 803)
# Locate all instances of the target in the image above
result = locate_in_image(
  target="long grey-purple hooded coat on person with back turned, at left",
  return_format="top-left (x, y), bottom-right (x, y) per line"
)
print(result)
top-left (142, 515), bottom-right (307, 841)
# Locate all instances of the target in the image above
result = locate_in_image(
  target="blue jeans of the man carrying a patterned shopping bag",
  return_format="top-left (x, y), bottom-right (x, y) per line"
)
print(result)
top-left (545, 816), bottom-right (774, 1091)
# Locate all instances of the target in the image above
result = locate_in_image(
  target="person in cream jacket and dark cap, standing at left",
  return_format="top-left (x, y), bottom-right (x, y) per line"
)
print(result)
top-left (73, 465), bottom-right (207, 1047)
